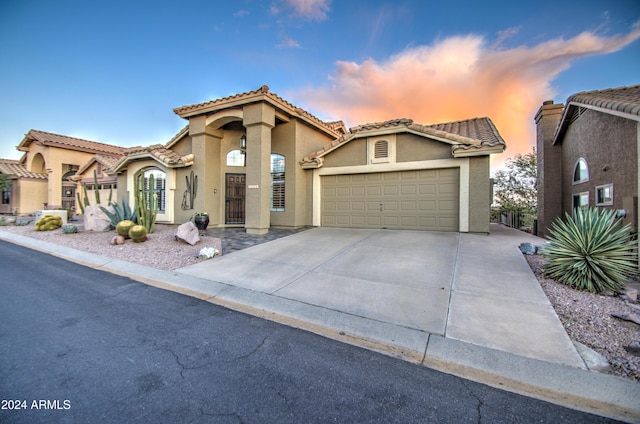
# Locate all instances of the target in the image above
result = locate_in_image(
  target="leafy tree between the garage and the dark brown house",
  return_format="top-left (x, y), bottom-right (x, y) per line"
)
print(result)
top-left (493, 150), bottom-right (538, 227)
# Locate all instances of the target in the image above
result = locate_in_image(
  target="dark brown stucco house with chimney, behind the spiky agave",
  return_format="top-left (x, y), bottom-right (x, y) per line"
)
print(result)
top-left (535, 85), bottom-right (640, 237)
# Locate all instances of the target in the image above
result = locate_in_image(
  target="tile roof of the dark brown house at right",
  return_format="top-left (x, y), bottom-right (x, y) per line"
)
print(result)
top-left (567, 85), bottom-right (640, 116)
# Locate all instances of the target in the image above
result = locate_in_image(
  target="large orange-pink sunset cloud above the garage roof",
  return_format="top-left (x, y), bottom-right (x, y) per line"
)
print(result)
top-left (292, 25), bottom-right (640, 167)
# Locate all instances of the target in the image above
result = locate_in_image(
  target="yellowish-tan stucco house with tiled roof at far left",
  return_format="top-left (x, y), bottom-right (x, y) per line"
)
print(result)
top-left (0, 130), bottom-right (123, 214)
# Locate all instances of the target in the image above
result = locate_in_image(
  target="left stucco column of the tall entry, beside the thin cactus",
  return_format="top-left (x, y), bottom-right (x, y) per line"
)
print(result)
top-left (189, 112), bottom-right (222, 226)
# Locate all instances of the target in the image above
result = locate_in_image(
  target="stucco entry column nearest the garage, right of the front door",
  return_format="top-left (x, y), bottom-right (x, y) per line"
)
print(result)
top-left (243, 103), bottom-right (275, 234)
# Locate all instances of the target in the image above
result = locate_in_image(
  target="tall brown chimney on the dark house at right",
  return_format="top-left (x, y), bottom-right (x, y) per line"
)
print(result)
top-left (535, 100), bottom-right (564, 238)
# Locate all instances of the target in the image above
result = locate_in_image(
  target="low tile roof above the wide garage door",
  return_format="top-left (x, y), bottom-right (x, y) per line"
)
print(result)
top-left (301, 117), bottom-right (506, 164)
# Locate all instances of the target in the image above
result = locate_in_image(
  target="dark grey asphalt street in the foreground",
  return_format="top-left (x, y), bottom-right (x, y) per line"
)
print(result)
top-left (0, 242), bottom-right (614, 423)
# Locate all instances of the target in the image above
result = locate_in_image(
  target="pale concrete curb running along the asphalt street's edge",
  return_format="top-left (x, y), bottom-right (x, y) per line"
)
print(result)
top-left (0, 231), bottom-right (640, 422)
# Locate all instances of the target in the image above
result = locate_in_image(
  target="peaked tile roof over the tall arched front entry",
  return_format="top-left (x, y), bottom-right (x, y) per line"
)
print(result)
top-left (173, 85), bottom-right (344, 137)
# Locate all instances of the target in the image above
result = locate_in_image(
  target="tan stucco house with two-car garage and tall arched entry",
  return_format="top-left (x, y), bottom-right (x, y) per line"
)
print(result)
top-left (109, 86), bottom-right (505, 234)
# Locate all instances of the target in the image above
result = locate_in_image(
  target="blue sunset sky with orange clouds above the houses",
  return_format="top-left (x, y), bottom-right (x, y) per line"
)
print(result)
top-left (0, 0), bottom-right (640, 169)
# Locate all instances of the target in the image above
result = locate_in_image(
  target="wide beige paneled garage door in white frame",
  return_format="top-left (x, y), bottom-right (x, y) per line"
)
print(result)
top-left (322, 168), bottom-right (460, 231)
